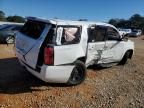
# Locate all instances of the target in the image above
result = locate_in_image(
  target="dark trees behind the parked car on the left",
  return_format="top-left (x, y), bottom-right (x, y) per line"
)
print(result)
top-left (0, 10), bottom-right (25, 23)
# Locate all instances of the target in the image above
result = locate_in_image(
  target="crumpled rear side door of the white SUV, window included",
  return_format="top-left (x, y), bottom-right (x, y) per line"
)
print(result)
top-left (86, 26), bottom-right (106, 66)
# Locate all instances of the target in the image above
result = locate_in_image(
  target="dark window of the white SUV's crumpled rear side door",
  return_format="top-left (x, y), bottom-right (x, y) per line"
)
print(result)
top-left (88, 26), bottom-right (106, 42)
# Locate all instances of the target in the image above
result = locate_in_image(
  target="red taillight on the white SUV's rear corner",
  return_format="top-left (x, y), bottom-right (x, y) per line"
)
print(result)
top-left (44, 47), bottom-right (54, 65)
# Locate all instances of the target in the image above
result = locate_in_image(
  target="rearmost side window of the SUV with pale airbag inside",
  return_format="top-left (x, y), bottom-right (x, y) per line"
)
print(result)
top-left (61, 27), bottom-right (81, 45)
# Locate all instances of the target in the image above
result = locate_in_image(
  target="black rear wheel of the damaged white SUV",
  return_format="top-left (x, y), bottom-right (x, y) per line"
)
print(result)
top-left (67, 60), bottom-right (86, 85)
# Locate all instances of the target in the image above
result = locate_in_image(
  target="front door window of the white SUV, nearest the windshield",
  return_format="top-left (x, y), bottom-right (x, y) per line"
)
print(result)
top-left (107, 27), bottom-right (120, 40)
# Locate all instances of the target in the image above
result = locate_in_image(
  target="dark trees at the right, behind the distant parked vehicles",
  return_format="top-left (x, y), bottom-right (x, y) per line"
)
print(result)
top-left (108, 14), bottom-right (144, 33)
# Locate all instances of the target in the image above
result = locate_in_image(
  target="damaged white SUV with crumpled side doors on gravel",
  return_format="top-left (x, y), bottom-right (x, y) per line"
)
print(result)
top-left (15, 17), bottom-right (134, 85)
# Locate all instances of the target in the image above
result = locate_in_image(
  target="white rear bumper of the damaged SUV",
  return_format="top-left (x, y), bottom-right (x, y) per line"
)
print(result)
top-left (19, 59), bottom-right (74, 83)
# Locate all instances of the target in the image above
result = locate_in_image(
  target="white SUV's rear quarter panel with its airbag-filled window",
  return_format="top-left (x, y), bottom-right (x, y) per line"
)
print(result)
top-left (54, 25), bottom-right (87, 65)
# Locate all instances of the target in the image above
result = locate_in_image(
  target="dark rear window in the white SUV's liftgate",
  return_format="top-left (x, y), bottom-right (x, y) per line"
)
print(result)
top-left (20, 21), bottom-right (45, 39)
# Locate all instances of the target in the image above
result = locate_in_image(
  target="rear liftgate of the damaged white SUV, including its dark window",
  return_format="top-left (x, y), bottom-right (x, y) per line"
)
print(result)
top-left (15, 20), bottom-right (50, 69)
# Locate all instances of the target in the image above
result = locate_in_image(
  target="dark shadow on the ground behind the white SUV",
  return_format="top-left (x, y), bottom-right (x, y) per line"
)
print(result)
top-left (0, 57), bottom-right (67, 94)
